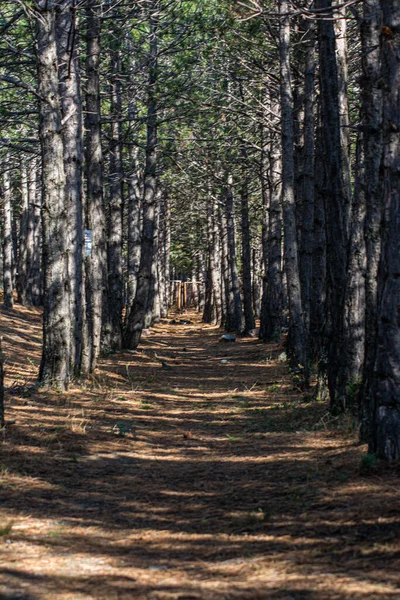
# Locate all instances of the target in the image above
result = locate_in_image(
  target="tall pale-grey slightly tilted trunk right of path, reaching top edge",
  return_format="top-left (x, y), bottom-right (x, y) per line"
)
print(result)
top-left (279, 0), bottom-right (307, 369)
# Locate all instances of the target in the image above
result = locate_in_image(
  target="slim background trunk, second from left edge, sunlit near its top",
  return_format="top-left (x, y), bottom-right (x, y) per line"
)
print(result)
top-left (16, 160), bottom-right (29, 306)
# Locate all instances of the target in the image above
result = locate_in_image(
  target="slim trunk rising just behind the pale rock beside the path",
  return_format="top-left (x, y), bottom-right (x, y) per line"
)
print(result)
top-left (225, 176), bottom-right (245, 334)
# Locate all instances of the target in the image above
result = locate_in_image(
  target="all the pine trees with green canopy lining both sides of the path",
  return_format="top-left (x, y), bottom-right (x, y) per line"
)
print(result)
top-left (0, 0), bottom-right (400, 460)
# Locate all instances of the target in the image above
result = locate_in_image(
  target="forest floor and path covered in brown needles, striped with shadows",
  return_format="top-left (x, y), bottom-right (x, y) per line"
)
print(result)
top-left (0, 306), bottom-right (400, 600)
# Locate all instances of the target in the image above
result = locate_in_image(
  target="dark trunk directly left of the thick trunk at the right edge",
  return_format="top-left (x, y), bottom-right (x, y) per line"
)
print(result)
top-left (361, 0), bottom-right (383, 442)
